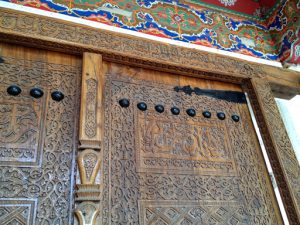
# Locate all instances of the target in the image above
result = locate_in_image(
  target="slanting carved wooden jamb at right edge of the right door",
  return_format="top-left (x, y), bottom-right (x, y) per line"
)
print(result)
top-left (248, 78), bottom-right (300, 225)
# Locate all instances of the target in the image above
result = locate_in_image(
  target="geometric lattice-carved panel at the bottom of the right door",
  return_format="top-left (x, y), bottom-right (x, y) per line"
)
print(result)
top-left (139, 201), bottom-right (249, 225)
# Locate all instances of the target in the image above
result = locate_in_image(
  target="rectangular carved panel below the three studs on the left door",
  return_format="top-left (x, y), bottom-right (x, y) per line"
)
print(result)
top-left (0, 97), bottom-right (45, 166)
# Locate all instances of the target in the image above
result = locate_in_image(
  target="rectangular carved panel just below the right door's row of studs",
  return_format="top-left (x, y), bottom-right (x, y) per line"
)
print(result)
top-left (135, 109), bottom-right (236, 175)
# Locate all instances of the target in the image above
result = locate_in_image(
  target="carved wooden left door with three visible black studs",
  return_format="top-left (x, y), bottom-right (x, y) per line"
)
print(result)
top-left (0, 44), bottom-right (81, 225)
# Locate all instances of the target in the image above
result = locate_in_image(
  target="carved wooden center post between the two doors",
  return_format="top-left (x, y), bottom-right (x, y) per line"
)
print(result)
top-left (75, 53), bottom-right (103, 225)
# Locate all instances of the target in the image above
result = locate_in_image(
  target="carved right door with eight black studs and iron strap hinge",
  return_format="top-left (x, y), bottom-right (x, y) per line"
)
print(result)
top-left (96, 63), bottom-right (282, 225)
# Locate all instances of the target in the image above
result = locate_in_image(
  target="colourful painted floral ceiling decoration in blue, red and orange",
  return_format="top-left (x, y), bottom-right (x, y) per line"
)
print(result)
top-left (4, 0), bottom-right (300, 63)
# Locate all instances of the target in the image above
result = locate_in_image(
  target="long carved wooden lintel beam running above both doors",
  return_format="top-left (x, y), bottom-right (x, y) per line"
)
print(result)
top-left (0, 8), bottom-right (300, 88)
